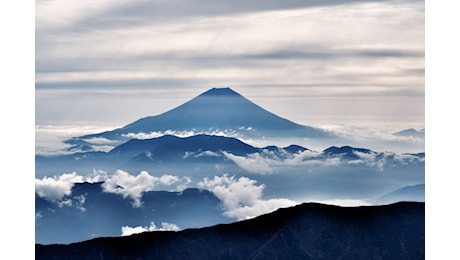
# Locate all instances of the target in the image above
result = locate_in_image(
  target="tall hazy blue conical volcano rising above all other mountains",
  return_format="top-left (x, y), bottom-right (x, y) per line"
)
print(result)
top-left (67, 88), bottom-right (330, 145)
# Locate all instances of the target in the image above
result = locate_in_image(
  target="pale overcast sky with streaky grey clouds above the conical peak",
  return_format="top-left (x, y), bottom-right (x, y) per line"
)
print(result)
top-left (35, 0), bottom-right (425, 128)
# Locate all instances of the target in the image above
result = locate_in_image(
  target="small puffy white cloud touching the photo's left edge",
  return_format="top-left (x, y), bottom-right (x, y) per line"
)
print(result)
top-left (35, 172), bottom-right (84, 201)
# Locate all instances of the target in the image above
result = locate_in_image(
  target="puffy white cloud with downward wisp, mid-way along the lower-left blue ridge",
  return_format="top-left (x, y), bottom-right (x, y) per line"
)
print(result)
top-left (102, 170), bottom-right (190, 207)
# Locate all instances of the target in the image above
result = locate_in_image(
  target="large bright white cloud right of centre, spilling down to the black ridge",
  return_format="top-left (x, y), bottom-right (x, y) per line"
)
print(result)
top-left (198, 174), bottom-right (297, 220)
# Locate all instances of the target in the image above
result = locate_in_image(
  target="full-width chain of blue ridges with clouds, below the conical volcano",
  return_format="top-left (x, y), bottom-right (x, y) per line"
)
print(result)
top-left (35, 134), bottom-right (424, 176)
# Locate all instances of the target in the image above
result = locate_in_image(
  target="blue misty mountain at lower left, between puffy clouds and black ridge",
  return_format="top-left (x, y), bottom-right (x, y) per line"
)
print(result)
top-left (35, 183), bottom-right (233, 244)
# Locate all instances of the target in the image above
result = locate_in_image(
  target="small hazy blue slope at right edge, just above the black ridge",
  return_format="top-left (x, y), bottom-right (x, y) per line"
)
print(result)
top-left (376, 184), bottom-right (425, 204)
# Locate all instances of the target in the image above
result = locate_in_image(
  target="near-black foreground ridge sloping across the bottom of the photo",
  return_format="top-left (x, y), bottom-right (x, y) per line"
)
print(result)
top-left (35, 202), bottom-right (425, 260)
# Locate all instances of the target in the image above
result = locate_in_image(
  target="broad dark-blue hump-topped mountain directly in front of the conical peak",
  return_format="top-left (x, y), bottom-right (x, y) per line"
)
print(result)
top-left (35, 134), bottom-right (308, 176)
